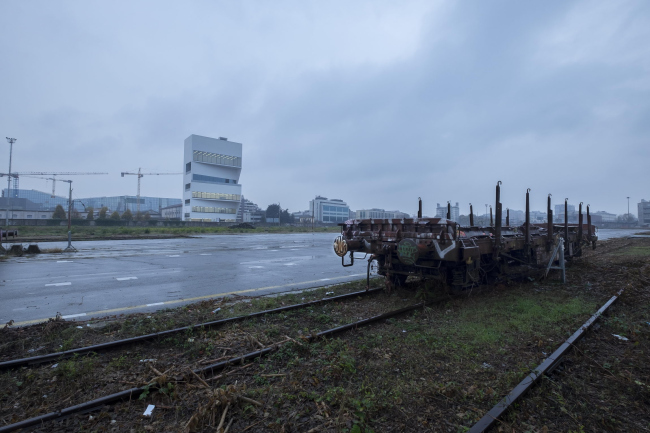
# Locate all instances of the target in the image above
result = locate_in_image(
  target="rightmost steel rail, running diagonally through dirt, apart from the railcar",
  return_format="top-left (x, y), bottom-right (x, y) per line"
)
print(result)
top-left (469, 289), bottom-right (624, 433)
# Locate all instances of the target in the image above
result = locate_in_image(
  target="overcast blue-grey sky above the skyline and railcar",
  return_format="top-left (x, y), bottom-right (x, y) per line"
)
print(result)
top-left (0, 0), bottom-right (650, 215)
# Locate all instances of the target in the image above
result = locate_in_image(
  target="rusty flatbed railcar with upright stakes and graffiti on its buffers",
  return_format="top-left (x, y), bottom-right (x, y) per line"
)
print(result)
top-left (334, 182), bottom-right (597, 292)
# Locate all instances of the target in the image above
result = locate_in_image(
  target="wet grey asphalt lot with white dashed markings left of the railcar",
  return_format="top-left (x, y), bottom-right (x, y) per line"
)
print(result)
top-left (0, 233), bottom-right (366, 325)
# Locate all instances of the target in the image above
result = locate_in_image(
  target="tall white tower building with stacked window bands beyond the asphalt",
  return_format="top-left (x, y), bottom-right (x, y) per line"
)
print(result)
top-left (183, 134), bottom-right (242, 221)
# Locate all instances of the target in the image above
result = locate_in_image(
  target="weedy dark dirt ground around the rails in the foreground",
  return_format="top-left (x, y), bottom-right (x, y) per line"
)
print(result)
top-left (0, 238), bottom-right (650, 433)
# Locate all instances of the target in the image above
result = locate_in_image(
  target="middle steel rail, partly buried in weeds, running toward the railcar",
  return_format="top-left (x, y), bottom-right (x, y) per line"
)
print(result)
top-left (0, 298), bottom-right (428, 433)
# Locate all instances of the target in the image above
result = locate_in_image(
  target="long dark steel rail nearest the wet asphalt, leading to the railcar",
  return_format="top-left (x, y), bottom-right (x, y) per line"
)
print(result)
top-left (0, 288), bottom-right (383, 371)
